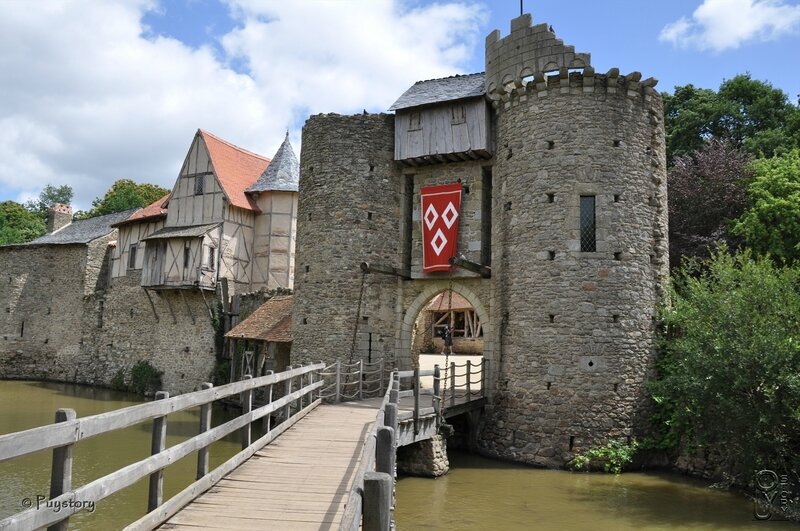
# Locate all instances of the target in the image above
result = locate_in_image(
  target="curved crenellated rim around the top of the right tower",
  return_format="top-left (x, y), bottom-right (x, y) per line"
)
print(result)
top-left (487, 66), bottom-right (658, 109)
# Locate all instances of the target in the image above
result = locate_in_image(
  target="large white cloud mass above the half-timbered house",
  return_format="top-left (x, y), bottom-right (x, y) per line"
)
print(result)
top-left (0, 0), bottom-right (485, 212)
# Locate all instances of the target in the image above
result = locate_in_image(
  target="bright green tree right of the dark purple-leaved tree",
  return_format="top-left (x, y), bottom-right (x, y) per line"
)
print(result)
top-left (732, 149), bottom-right (800, 263)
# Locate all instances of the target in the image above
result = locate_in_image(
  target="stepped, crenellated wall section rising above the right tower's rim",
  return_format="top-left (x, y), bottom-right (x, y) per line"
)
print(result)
top-left (486, 14), bottom-right (591, 92)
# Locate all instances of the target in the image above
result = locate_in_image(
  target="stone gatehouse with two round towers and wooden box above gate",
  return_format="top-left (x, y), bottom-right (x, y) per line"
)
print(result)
top-left (292, 15), bottom-right (668, 466)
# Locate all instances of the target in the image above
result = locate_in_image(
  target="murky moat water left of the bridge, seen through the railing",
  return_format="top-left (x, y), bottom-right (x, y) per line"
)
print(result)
top-left (0, 381), bottom-right (241, 530)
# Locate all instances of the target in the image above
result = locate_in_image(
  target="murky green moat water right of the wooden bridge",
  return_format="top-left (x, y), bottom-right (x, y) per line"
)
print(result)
top-left (396, 452), bottom-right (798, 531)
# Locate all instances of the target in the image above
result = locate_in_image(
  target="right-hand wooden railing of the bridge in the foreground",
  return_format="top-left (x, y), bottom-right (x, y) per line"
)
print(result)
top-left (339, 371), bottom-right (400, 531)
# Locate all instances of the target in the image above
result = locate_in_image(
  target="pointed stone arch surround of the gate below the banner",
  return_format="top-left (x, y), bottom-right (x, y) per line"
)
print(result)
top-left (395, 280), bottom-right (494, 385)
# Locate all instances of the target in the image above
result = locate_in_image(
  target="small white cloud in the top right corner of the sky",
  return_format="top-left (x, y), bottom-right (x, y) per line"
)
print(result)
top-left (659, 0), bottom-right (800, 52)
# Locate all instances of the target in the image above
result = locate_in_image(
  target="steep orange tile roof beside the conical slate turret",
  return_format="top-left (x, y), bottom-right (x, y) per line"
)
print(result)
top-left (197, 129), bottom-right (270, 212)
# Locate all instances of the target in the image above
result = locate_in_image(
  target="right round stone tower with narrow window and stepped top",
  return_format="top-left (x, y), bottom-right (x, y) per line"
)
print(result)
top-left (481, 15), bottom-right (668, 466)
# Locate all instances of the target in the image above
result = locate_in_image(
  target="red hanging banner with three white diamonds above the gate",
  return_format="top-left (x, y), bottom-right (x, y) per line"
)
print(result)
top-left (420, 183), bottom-right (461, 273)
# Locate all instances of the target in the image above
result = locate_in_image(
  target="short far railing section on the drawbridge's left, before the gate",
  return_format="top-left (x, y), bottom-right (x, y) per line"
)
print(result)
top-left (319, 358), bottom-right (387, 402)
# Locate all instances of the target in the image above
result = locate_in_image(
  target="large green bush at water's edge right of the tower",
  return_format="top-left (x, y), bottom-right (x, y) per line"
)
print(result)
top-left (650, 248), bottom-right (800, 483)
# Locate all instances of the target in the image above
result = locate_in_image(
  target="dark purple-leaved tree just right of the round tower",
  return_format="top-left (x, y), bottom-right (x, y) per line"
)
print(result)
top-left (667, 140), bottom-right (750, 267)
